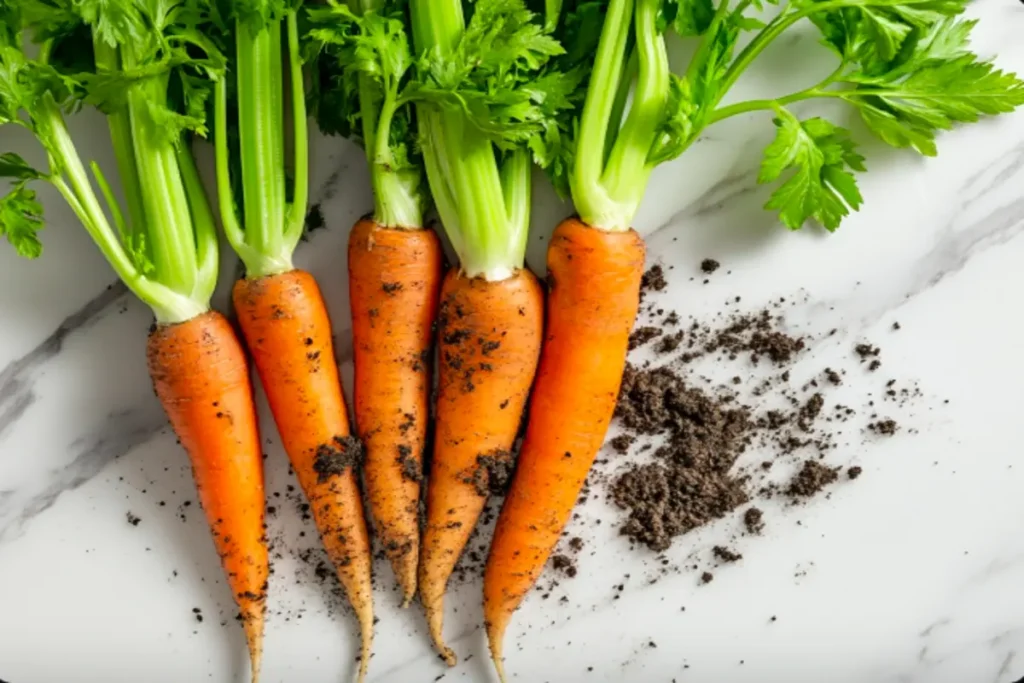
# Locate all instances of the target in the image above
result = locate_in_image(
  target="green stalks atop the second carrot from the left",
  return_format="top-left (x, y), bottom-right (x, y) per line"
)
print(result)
top-left (201, 0), bottom-right (309, 278)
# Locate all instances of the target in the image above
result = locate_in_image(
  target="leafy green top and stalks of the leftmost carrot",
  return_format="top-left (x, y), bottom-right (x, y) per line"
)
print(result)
top-left (0, 0), bottom-right (223, 323)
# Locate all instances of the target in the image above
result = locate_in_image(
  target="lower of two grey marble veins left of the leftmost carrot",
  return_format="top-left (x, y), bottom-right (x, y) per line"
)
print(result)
top-left (0, 409), bottom-right (167, 542)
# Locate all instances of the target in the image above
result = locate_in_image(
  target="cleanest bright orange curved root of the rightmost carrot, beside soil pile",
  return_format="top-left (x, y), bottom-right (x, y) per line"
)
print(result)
top-left (483, 219), bottom-right (644, 680)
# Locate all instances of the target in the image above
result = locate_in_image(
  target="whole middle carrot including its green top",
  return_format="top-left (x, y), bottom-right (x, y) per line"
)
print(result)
top-left (309, 0), bottom-right (442, 606)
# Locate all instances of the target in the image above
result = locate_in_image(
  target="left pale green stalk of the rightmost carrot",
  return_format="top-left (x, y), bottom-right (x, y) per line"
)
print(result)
top-left (570, 0), bottom-right (634, 227)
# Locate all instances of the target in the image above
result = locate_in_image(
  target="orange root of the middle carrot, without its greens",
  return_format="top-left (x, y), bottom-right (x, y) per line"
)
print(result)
top-left (348, 220), bottom-right (441, 606)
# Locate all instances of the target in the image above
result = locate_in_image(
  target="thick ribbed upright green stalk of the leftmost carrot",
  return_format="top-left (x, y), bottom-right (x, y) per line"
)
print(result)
top-left (122, 48), bottom-right (198, 295)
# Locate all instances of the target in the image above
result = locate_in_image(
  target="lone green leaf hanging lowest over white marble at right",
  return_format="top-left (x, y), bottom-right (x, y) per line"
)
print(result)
top-left (758, 109), bottom-right (865, 230)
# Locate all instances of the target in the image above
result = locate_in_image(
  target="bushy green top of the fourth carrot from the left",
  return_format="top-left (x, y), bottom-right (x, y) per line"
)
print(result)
top-left (406, 0), bottom-right (580, 280)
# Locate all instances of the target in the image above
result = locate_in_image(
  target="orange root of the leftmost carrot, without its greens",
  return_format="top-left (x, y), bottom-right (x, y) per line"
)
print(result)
top-left (146, 311), bottom-right (269, 682)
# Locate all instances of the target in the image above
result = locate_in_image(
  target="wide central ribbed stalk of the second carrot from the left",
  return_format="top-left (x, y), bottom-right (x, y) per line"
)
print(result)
top-left (238, 20), bottom-right (292, 278)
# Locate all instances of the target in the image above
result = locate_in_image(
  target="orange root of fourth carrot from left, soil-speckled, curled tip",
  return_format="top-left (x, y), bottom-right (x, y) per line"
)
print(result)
top-left (420, 269), bottom-right (543, 666)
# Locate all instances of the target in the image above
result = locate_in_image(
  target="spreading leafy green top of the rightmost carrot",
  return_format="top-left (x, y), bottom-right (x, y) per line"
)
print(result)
top-left (549, 0), bottom-right (1024, 230)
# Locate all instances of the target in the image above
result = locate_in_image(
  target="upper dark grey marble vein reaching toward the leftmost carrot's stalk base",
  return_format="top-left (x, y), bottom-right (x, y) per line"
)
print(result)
top-left (0, 282), bottom-right (128, 444)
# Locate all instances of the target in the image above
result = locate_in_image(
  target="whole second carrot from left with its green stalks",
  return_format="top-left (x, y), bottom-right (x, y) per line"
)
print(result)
top-left (208, 7), bottom-right (374, 681)
